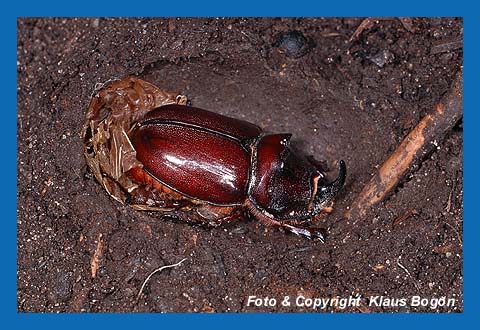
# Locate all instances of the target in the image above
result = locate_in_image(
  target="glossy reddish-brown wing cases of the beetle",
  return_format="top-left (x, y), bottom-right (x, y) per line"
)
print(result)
top-left (132, 105), bottom-right (256, 205)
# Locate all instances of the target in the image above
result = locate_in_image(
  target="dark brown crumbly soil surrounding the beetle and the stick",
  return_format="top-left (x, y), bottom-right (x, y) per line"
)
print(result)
top-left (17, 18), bottom-right (463, 312)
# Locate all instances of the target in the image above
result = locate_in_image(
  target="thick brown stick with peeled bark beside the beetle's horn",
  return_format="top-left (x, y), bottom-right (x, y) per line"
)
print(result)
top-left (344, 70), bottom-right (463, 222)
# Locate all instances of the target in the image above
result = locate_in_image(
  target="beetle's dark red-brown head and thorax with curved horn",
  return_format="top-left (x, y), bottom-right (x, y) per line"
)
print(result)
top-left (248, 134), bottom-right (346, 221)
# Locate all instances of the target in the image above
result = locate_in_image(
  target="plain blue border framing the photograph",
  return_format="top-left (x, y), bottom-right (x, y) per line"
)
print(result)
top-left (5, 0), bottom-right (474, 329)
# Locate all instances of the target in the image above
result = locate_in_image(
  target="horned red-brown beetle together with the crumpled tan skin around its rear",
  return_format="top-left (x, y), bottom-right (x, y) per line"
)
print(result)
top-left (82, 77), bottom-right (346, 242)
